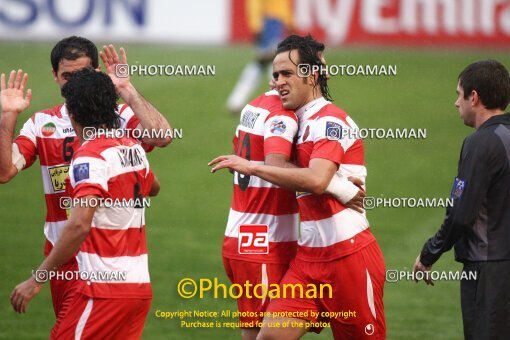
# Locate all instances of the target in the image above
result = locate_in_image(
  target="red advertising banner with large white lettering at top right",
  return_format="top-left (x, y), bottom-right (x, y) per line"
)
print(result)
top-left (230, 0), bottom-right (510, 48)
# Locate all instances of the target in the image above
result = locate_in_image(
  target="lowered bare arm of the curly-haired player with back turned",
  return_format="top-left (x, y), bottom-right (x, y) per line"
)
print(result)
top-left (11, 196), bottom-right (96, 313)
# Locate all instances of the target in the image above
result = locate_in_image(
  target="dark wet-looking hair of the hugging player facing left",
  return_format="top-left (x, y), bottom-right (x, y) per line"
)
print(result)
top-left (276, 35), bottom-right (332, 101)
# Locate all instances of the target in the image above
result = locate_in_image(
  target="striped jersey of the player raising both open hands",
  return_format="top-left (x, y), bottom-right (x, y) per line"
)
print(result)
top-left (14, 104), bottom-right (149, 256)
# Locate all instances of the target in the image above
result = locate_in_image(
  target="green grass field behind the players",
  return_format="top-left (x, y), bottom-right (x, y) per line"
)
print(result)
top-left (0, 43), bottom-right (510, 339)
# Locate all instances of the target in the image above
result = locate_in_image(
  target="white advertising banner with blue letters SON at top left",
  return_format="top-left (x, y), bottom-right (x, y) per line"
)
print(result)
top-left (0, 0), bottom-right (230, 44)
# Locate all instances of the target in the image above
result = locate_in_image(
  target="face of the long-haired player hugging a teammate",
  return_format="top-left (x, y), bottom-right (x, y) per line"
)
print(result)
top-left (273, 50), bottom-right (313, 110)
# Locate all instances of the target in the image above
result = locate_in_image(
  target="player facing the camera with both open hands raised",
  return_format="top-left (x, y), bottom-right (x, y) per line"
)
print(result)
top-left (0, 36), bottom-right (170, 324)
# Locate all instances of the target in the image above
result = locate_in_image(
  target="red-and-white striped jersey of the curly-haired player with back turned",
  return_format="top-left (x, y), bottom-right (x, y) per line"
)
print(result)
top-left (69, 137), bottom-right (154, 298)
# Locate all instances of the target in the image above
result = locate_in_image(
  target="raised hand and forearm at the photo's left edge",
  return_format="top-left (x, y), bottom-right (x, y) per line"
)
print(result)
top-left (0, 69), bottom-right (32, 184)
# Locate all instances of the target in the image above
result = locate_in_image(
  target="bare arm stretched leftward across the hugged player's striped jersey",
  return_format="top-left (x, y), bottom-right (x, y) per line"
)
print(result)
top-left (209, 155), bottom-right (337, 195)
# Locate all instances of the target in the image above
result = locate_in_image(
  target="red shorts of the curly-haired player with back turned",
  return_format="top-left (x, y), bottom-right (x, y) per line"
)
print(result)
top-left (50, 294), bottom-right (151, 340)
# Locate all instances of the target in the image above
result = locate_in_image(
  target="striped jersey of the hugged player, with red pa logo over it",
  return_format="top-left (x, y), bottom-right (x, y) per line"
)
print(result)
top-left (223, 91), bottom-right (298, 263)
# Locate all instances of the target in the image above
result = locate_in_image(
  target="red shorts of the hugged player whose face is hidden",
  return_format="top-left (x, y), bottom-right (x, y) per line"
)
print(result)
top-left (223, 257), bottom-right (289, 328)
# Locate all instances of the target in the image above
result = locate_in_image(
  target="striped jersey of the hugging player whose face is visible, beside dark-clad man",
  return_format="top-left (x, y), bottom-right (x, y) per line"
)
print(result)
top-left (296, 98), bottom-right (375, 262)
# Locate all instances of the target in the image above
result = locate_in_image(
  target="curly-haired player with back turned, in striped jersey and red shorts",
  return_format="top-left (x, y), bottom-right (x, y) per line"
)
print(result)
top-left (11, 69), bottom-right (159, 339)
